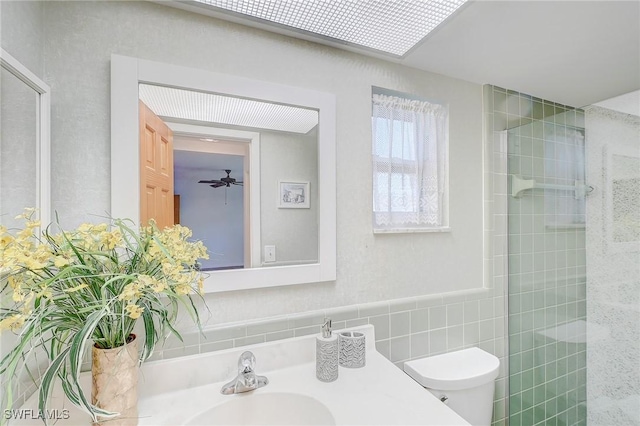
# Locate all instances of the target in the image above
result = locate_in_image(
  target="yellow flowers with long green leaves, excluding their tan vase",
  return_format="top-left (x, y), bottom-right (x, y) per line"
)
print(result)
top-left (0, 209), bottom-right (208, 422)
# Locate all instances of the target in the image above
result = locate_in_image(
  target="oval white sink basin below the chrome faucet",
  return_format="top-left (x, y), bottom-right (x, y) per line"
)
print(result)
top-left (185, 392), bottom-right (336, 425)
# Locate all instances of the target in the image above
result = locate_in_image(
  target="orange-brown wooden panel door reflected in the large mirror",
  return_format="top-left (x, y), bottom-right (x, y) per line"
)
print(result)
top-left (140, 101), bottom-right (174, 229)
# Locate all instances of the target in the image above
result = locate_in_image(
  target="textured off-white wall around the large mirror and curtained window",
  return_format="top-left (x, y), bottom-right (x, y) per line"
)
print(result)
top-left (15, 2), bottom-right (483, 323)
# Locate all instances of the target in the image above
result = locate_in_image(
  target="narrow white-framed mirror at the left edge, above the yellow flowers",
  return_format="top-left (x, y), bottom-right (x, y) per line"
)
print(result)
top-left (0, 49), bottom-right (51, 228)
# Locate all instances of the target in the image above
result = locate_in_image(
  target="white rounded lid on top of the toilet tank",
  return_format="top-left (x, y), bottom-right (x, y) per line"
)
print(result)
top-left (404, 348), bottom-right (500, 390)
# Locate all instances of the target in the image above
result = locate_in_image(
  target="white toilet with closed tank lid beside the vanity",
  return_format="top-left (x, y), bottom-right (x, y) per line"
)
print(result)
top-left (404, 348), bottom-right (500, 426)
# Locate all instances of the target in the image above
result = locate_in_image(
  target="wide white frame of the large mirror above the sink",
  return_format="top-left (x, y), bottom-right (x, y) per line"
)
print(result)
top-left (111, 55), bottom-right (336, 293)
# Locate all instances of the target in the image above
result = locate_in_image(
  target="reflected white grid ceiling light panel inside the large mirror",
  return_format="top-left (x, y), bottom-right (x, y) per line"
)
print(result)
top-left (139, 84), bottom-right (318, 133)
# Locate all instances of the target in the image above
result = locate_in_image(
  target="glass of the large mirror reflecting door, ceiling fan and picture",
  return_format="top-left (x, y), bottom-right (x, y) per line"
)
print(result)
top-left (139, 84), bottom-right (319, 270)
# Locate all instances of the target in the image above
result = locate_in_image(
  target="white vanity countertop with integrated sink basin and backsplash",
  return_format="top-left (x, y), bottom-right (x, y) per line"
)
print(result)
top-left (11, 325), bottom-right (469, 426)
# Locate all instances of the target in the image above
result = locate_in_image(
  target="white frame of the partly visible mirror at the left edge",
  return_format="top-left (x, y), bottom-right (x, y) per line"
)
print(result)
top-left (0, 49), bottom-right (51, 227)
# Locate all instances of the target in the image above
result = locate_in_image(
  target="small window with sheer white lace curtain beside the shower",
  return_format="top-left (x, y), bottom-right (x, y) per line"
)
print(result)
top-left (371, 89), bottom-right (449, 232)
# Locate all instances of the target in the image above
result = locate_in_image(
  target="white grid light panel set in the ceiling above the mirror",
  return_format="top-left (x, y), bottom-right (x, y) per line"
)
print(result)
top-left (195, 0), bottom-right (467, 56)
